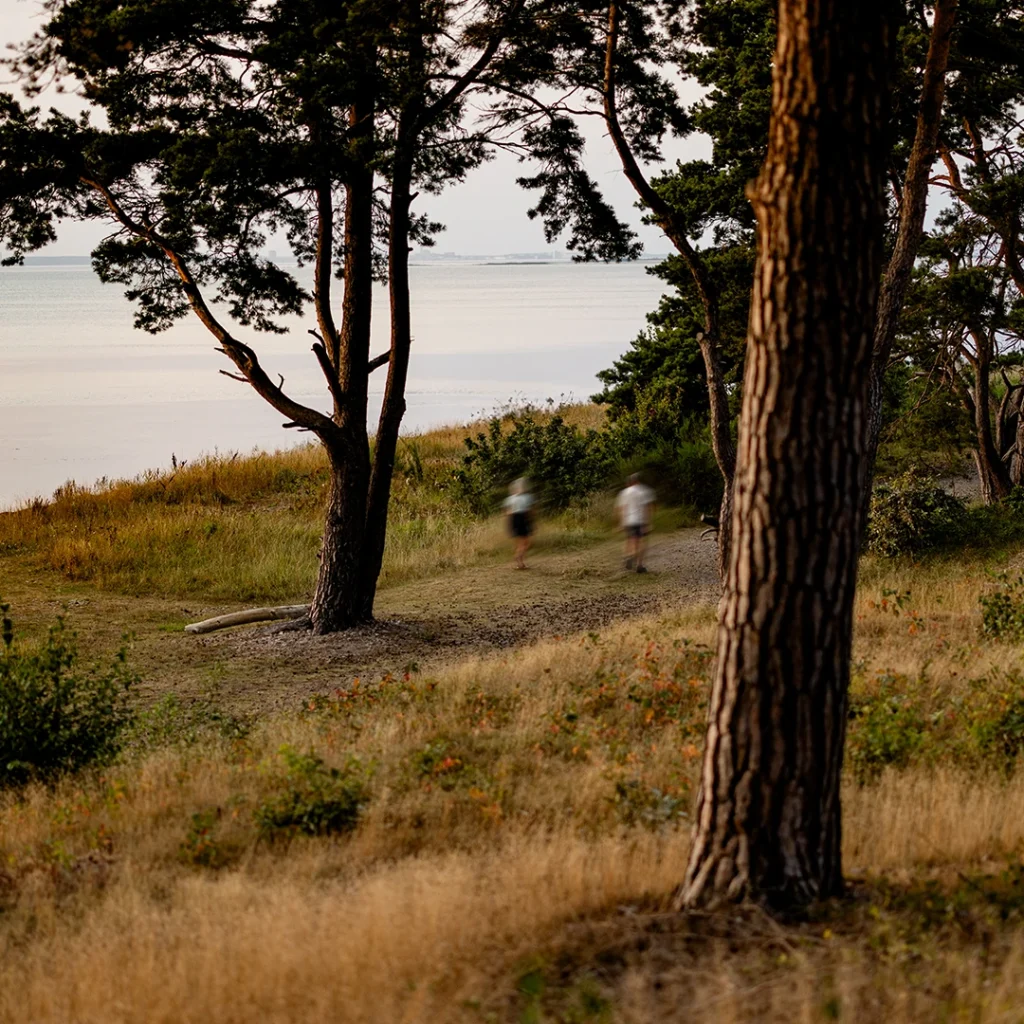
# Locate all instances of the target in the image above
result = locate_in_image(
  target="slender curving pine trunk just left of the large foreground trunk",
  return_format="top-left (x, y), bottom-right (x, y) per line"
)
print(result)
top-left (602, 0), bottom-right (736, 579)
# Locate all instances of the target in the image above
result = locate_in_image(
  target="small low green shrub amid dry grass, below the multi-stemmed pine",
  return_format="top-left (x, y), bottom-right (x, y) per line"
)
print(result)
top-left (254, 745), bottom-right (372, 840)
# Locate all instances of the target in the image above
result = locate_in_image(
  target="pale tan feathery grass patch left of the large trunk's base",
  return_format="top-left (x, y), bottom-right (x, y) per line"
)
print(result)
top-left (0, 835), bottom-right (684, 1024)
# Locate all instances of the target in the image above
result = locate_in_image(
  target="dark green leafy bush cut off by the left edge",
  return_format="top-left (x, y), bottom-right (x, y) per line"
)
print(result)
top-left (0, 604), bottom-right (137, 788)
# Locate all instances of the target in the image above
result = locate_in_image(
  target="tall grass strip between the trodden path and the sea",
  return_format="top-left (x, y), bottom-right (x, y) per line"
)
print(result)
top-left (0, 406), bottom-right (604, 602)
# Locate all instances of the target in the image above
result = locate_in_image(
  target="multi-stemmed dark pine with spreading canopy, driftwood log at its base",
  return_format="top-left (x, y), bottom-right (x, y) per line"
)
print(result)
top-left (0, 0), bottom-right (628, 633)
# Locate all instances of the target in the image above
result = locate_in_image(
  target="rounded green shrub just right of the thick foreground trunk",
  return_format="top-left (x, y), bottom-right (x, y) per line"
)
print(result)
top-left (867, 471), bottom-right (969, 558)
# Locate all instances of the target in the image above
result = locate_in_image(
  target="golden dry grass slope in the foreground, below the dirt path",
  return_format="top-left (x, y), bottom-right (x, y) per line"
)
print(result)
top-left (0, 565), bottom-right (1024, 1024)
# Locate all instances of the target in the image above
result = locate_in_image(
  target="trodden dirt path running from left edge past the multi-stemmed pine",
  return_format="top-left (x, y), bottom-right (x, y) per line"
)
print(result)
top-left (0, 529), bottom-right (718, 714)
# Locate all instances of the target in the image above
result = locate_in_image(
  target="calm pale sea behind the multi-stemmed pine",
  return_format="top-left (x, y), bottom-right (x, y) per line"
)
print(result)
top-left (0, 261), bottom-right (663, 508)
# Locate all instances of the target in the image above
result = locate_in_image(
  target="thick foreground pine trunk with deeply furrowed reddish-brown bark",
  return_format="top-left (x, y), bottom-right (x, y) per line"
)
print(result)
top-left (679, 0), bottom-right (891, 906)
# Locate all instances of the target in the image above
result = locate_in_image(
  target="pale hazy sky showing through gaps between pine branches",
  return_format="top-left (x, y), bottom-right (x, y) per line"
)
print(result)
top-left (0, 0), bottom-right (709, 255)
